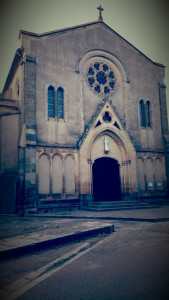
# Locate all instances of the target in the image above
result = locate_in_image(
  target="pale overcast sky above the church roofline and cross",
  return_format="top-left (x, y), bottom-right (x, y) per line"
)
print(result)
top-left (0, 0), bottom-right (169, 117)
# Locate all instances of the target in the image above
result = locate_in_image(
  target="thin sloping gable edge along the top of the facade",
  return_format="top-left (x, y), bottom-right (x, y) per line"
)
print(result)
top-left (19, 20), bottom-right (165, 67)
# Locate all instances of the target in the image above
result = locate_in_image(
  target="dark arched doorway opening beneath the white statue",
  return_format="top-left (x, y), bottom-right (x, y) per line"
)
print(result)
top-left (92, 157), bottom-right (121, 201)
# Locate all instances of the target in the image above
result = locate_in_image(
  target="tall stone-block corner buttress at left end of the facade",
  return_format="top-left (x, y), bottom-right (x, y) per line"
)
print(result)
top-left (24, 55), bottom-right (37, 208)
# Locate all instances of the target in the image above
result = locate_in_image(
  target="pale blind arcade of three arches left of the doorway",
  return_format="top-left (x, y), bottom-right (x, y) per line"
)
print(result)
top-left (36, 147), bottom-right (79, 200)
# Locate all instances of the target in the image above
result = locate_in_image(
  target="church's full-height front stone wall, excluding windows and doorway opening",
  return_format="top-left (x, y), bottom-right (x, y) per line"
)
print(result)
top-left (18, 22), bottom-right (168, 203)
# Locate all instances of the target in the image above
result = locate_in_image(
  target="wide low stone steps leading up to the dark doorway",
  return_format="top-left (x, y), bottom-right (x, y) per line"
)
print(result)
top-left (82, 200), bottom-right (161, 211)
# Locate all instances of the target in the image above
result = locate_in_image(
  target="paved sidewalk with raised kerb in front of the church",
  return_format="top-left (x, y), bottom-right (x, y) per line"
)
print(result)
top-left (0, 206), bottom-right (169, 259)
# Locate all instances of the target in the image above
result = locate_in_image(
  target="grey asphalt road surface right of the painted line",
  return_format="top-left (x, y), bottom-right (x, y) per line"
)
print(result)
top-left (14, 222), bottom-right (169, 300)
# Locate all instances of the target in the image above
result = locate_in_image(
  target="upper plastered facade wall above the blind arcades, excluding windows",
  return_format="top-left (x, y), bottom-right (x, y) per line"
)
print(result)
top-left (22, 23), bottom-right (164, 149)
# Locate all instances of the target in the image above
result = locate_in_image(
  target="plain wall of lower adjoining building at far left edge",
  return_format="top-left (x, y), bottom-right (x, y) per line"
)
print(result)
top-left (0, 114), bottom-right (19, 213)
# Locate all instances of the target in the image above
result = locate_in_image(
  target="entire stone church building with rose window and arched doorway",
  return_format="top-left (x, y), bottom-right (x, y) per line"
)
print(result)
top-left (0, 14), bottom-right (169, 212)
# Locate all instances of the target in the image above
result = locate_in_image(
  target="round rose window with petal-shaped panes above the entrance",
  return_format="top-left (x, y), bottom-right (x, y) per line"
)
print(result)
top-left (87, 62), bottom-right (115, 95)
